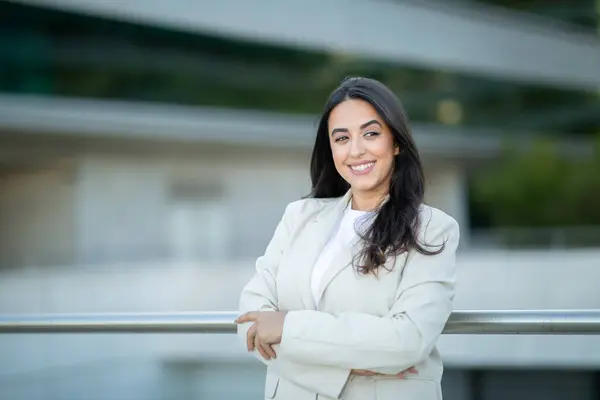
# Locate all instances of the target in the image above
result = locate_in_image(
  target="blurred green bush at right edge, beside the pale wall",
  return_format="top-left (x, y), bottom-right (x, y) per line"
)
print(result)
top-left (471, 137), bottom-right (600, 227)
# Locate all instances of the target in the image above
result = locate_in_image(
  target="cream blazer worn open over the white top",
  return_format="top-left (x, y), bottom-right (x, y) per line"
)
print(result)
top-left (238, 192), bottom-right (459, 400)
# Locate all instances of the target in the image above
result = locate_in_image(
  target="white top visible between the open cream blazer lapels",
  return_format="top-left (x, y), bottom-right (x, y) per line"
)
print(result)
top-left (310, 206), bottom-right (371, 306)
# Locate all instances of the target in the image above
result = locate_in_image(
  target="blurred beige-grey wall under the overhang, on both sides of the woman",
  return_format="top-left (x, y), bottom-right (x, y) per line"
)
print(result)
top-left (0, 147), bottom-right (468, 267)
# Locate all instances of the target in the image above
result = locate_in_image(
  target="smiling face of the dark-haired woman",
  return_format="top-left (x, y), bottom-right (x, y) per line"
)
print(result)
top-left (328, 99), bottom-right (400, 194)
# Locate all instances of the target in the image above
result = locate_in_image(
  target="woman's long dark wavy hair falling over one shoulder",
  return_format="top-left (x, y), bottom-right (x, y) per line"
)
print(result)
top-left (309, 77), bottom-right (444, 274)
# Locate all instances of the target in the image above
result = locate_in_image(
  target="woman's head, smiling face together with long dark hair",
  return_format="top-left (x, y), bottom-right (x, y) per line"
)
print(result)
top-left (311, 78), bottom-right (441, 272)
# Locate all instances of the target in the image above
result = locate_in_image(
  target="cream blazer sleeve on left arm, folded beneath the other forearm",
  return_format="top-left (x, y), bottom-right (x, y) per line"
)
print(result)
top-left (238, 203), bottom-right (350, 398)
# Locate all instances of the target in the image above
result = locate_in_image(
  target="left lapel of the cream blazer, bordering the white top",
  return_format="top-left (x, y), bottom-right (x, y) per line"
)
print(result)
top-left (296, 191), bottom-right (352, 310)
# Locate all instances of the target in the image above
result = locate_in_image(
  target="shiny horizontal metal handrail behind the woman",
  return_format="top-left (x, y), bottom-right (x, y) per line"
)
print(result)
top-left (0, 310), bottom-right (600, 335)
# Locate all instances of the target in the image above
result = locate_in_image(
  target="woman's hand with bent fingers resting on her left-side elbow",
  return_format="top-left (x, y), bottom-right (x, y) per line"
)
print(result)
top-left (235, 311), bottom-right (286, 360)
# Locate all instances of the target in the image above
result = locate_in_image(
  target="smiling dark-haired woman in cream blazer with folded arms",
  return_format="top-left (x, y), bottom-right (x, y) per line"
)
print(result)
top-left (236, 78), bottom-right (459, 400)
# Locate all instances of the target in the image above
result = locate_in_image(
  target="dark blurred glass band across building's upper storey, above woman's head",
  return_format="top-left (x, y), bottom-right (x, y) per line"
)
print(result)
top-left (0, 3), bottom-right (600, 134)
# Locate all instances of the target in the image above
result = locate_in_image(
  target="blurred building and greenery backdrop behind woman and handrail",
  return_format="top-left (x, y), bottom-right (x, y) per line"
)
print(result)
top-left (0, 0), bottom-right (600, 400)
